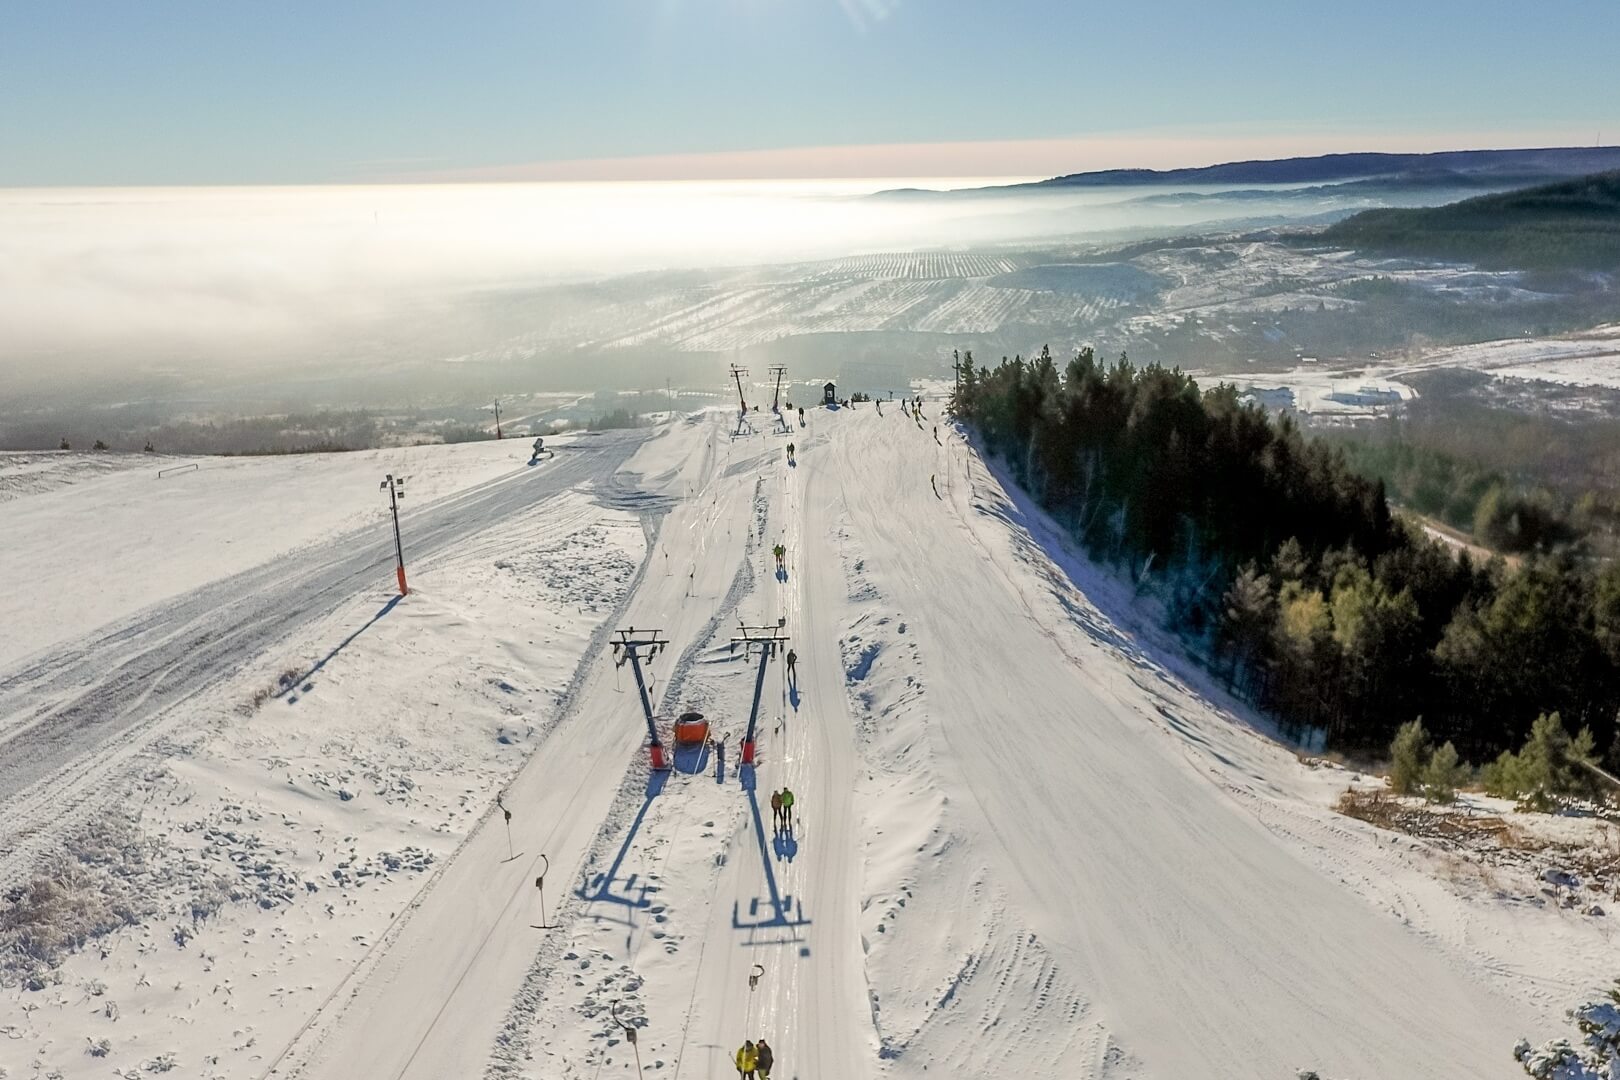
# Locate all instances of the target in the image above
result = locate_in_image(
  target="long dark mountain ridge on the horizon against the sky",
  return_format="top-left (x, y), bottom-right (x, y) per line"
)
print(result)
top-left (876, 146), bottom-right (1620, 198)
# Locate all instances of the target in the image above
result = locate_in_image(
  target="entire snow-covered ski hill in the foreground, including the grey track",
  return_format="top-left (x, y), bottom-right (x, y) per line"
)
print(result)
top-left (0, 403), bottom-right (1620, 1080)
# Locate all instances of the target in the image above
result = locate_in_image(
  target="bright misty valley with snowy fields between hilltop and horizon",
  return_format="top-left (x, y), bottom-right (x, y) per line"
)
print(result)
top-left (9, 156), bottom-right (1615, 452)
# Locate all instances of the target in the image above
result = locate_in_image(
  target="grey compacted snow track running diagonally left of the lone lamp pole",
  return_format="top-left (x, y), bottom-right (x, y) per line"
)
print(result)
top-left (0, 432), bottom-right (645, 887)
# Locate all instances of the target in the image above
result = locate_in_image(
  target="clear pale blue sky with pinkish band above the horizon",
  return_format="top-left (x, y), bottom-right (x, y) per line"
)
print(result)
top-left (0, 0), bottom-right (1620, 185)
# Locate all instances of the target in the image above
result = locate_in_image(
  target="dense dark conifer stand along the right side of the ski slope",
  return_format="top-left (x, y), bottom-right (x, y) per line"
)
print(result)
top-left (953, 348), bottom-right (1620, 761)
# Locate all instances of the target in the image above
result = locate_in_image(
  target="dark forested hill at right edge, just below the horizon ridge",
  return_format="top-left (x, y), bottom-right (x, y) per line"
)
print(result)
top-left (1320, 172), bottom-right (1620, 270)
